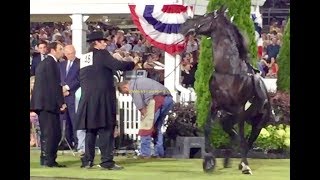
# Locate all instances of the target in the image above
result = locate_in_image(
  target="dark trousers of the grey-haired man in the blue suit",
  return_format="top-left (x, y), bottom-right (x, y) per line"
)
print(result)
top-left (60, 103), bottom-right (78, 147)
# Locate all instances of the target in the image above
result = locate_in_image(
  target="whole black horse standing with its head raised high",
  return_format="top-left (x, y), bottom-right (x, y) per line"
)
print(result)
top-left (180, 7), bottom-right (274, 174)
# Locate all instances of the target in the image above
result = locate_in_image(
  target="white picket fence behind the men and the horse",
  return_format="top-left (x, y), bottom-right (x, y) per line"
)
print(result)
top-left (117, 79), bottom-right (277, 140)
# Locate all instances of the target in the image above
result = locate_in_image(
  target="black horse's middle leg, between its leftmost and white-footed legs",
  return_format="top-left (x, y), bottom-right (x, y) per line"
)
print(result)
top-left (220, 115), bottom-right (239, 168)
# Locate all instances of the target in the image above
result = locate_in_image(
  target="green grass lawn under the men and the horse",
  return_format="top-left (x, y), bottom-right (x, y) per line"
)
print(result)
top-left (30, 151), bottom-right (290, 180)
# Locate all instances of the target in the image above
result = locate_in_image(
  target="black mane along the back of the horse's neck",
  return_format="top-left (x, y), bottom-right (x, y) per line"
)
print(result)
top-left (225, 18), bottom-right (248, 62)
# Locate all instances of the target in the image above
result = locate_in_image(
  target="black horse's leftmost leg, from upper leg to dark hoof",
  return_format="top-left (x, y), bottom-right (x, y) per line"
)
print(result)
top-left (202, 103), bottom-right (217, 173)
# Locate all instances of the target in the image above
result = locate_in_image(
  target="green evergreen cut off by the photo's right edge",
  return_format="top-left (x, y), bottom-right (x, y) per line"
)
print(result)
top-left (277, 19), bottom-right (290, 93)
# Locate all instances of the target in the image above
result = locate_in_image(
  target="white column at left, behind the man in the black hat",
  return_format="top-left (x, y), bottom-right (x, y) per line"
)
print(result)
top-left (70, 14), bottom-right (89, 58)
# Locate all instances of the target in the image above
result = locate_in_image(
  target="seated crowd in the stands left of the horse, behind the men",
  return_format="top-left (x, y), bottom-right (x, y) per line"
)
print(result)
top-left (30, 23), bottom-right (199, 87)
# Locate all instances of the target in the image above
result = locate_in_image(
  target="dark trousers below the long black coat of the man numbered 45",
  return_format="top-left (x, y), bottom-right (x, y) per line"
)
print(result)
top-left (84, 128), bottom-right (115, 168)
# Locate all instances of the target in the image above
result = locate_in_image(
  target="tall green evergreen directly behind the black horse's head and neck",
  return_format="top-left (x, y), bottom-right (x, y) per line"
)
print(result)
top-left (195, 0), bottom-right (257, 127)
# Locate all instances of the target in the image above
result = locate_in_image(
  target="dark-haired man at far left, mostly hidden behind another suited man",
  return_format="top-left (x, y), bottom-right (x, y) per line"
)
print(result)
top-left (30, 40), bottom-right (48, 77)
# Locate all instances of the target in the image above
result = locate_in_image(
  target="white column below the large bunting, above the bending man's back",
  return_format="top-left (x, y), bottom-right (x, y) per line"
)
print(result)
top-left (164, 53), bottom-right (176, 102)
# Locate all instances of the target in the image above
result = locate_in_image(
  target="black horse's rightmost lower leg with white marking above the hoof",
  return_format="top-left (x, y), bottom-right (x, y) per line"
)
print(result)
top-left (239, 121), bottom-right (252, 174)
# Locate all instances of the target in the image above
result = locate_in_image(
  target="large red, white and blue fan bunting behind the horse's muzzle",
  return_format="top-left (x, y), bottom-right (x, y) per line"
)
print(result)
top-left (129, 4), bottom-right (193, 55)
